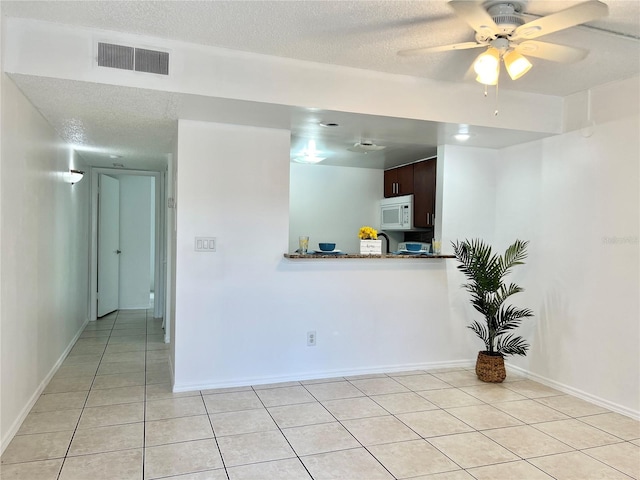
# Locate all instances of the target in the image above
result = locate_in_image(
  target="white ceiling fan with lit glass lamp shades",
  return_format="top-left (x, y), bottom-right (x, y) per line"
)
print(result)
top-left (398, 0), bottom-right (609, 85)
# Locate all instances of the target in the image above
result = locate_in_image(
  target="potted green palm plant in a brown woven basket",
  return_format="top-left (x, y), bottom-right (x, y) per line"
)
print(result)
top-left (452, 239), bottom-right (533, 382)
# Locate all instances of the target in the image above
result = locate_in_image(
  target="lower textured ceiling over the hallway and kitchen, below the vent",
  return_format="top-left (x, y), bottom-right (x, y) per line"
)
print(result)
top-left (11, 74), bottom-right (545, 170)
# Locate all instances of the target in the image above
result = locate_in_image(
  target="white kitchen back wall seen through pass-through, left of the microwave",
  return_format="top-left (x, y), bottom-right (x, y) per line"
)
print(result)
top-left (288, 163), bottom-right (384, 253)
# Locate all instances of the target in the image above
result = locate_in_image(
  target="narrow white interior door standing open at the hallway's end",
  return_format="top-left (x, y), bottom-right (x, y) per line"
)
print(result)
top-left (98, 174), bottom-right (121, 317)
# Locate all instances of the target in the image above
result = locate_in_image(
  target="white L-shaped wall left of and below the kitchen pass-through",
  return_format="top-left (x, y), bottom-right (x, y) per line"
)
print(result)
top-left (174, 121), bottom-right (475, 390)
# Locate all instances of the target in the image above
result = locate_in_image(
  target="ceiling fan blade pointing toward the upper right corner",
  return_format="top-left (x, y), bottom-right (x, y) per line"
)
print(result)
top-left (509, 0), bottom-right (609, 40)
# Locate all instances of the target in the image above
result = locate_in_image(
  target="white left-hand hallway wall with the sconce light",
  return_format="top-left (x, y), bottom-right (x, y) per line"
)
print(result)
top-left (0, 74), bottom-right (90, 449)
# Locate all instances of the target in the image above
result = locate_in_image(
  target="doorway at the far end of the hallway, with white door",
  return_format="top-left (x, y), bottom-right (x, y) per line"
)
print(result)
top-left (89, 168), bottom-right (168, 338)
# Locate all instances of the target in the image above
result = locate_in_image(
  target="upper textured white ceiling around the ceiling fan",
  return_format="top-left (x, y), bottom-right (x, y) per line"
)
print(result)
top-left (2, 0), bottom-right (640, 96)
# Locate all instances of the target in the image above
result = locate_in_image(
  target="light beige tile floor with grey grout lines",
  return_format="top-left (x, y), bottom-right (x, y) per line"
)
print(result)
top-left (0, 310), bottom-right (640, 480)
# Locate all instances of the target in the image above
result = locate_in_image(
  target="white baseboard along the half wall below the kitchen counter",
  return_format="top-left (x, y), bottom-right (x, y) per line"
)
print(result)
top-left (173, 359), bottom-right (475, 393)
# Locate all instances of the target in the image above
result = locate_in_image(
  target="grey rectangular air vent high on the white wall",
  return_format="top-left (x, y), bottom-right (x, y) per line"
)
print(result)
top-left (98, 42), bottom-right (169, 75)
